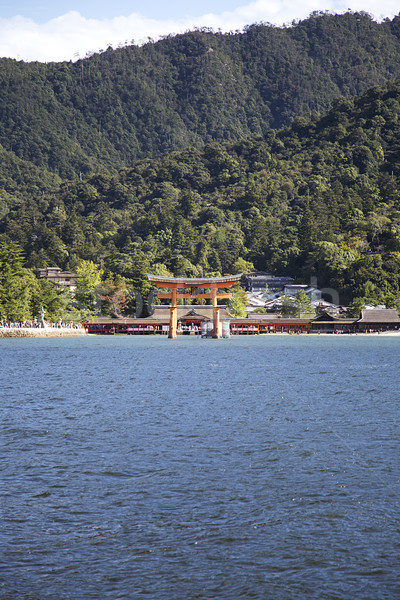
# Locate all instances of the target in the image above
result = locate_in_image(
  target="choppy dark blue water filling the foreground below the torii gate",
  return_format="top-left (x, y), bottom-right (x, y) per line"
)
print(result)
top-left (0, 336), bottom-right (400, 600)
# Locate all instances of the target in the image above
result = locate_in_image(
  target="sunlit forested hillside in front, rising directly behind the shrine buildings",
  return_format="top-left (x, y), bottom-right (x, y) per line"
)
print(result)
top-left (0, 82), bottom-right (400, 306)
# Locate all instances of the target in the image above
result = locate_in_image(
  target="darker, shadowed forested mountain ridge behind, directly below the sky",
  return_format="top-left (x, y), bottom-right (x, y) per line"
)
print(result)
top-left (0, 13), bottom-right (400, 179)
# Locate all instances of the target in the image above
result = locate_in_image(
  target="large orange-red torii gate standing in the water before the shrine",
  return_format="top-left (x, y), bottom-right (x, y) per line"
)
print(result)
top-left (147, 273), bottom-right (242, 339)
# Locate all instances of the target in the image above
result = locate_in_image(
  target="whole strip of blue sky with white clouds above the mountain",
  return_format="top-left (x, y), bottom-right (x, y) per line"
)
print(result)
top-left (0, 0), bottom-right (400, 62)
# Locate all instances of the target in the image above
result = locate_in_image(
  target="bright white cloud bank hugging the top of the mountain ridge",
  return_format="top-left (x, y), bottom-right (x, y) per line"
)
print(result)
top-left (0, 0), bottom-right (399, 62)
